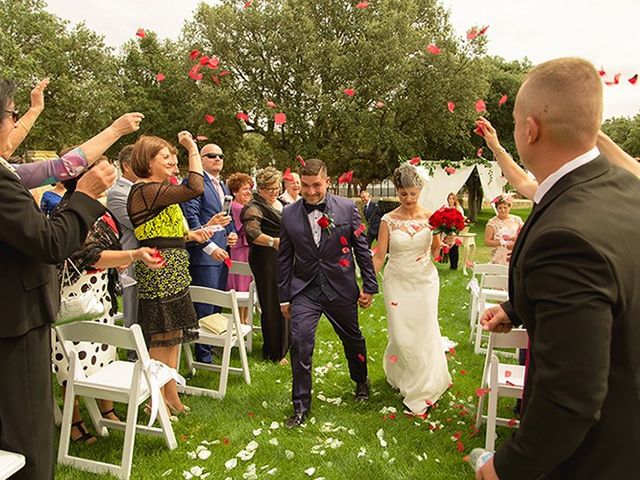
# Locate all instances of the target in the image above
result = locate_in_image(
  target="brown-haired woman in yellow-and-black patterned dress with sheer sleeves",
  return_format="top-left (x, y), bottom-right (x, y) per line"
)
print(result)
top-left (127, 132), bottom-right (204, 414)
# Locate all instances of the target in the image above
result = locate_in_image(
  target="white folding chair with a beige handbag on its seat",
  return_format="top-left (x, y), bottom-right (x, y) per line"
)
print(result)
top-left (178, 285), bottom-right (252, 399)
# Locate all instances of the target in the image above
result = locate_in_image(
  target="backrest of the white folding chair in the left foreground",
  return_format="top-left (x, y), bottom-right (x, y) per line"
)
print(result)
top-left (54, 321), bottom-right (149, 365)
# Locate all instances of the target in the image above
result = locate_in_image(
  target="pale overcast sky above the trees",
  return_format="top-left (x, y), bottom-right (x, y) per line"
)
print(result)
top-left (47, 0), bottom-right (640, 118)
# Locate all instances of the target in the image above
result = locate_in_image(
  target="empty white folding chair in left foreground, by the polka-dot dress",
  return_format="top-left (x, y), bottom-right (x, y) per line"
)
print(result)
top-left (55, 322), bottom-right (178, 479)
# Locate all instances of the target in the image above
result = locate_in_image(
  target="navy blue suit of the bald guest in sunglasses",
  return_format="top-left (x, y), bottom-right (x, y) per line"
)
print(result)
top-left (180, 172), bottom-right (235, 363)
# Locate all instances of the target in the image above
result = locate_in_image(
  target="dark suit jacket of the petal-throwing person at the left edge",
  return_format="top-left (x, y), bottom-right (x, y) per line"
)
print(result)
top-left (0, 167), bottom-right (105, 338)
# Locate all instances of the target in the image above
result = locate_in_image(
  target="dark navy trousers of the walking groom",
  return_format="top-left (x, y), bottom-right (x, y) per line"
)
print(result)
top-left (291, 289), bottom-right (367, 412)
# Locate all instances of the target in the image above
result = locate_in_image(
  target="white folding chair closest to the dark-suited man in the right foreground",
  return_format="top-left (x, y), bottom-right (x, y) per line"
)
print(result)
top-left (476, 329), bottom-right (529, 451)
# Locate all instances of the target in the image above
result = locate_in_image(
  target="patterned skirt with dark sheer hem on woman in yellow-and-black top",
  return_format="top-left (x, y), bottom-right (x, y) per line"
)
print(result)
top-left (136, 248), bottom-right (198, 347)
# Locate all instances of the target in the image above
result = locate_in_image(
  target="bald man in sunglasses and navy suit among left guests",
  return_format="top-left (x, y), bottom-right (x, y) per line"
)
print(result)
top-left (180, 143), bottom-right (238, 363)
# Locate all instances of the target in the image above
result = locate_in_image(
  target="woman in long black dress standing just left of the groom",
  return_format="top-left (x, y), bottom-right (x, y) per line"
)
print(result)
top-left (240, 167), bottom-right (289, 364)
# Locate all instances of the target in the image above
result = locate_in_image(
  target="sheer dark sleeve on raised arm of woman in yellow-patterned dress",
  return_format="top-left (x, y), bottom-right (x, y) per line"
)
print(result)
top-left (127, 172), bottom-right (204, 228)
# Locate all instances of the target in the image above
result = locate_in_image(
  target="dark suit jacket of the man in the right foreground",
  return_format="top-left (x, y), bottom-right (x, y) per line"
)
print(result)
top-left (495, 157), bottom-right (640, 480)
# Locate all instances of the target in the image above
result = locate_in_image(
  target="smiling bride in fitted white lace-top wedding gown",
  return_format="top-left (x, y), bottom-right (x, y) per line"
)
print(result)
top-left (373, 164), bottom-right (451, 415)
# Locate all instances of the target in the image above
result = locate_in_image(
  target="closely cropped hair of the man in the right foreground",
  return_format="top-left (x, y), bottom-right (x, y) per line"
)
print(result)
top-left (517, 58), bottom-right (603, 146)
